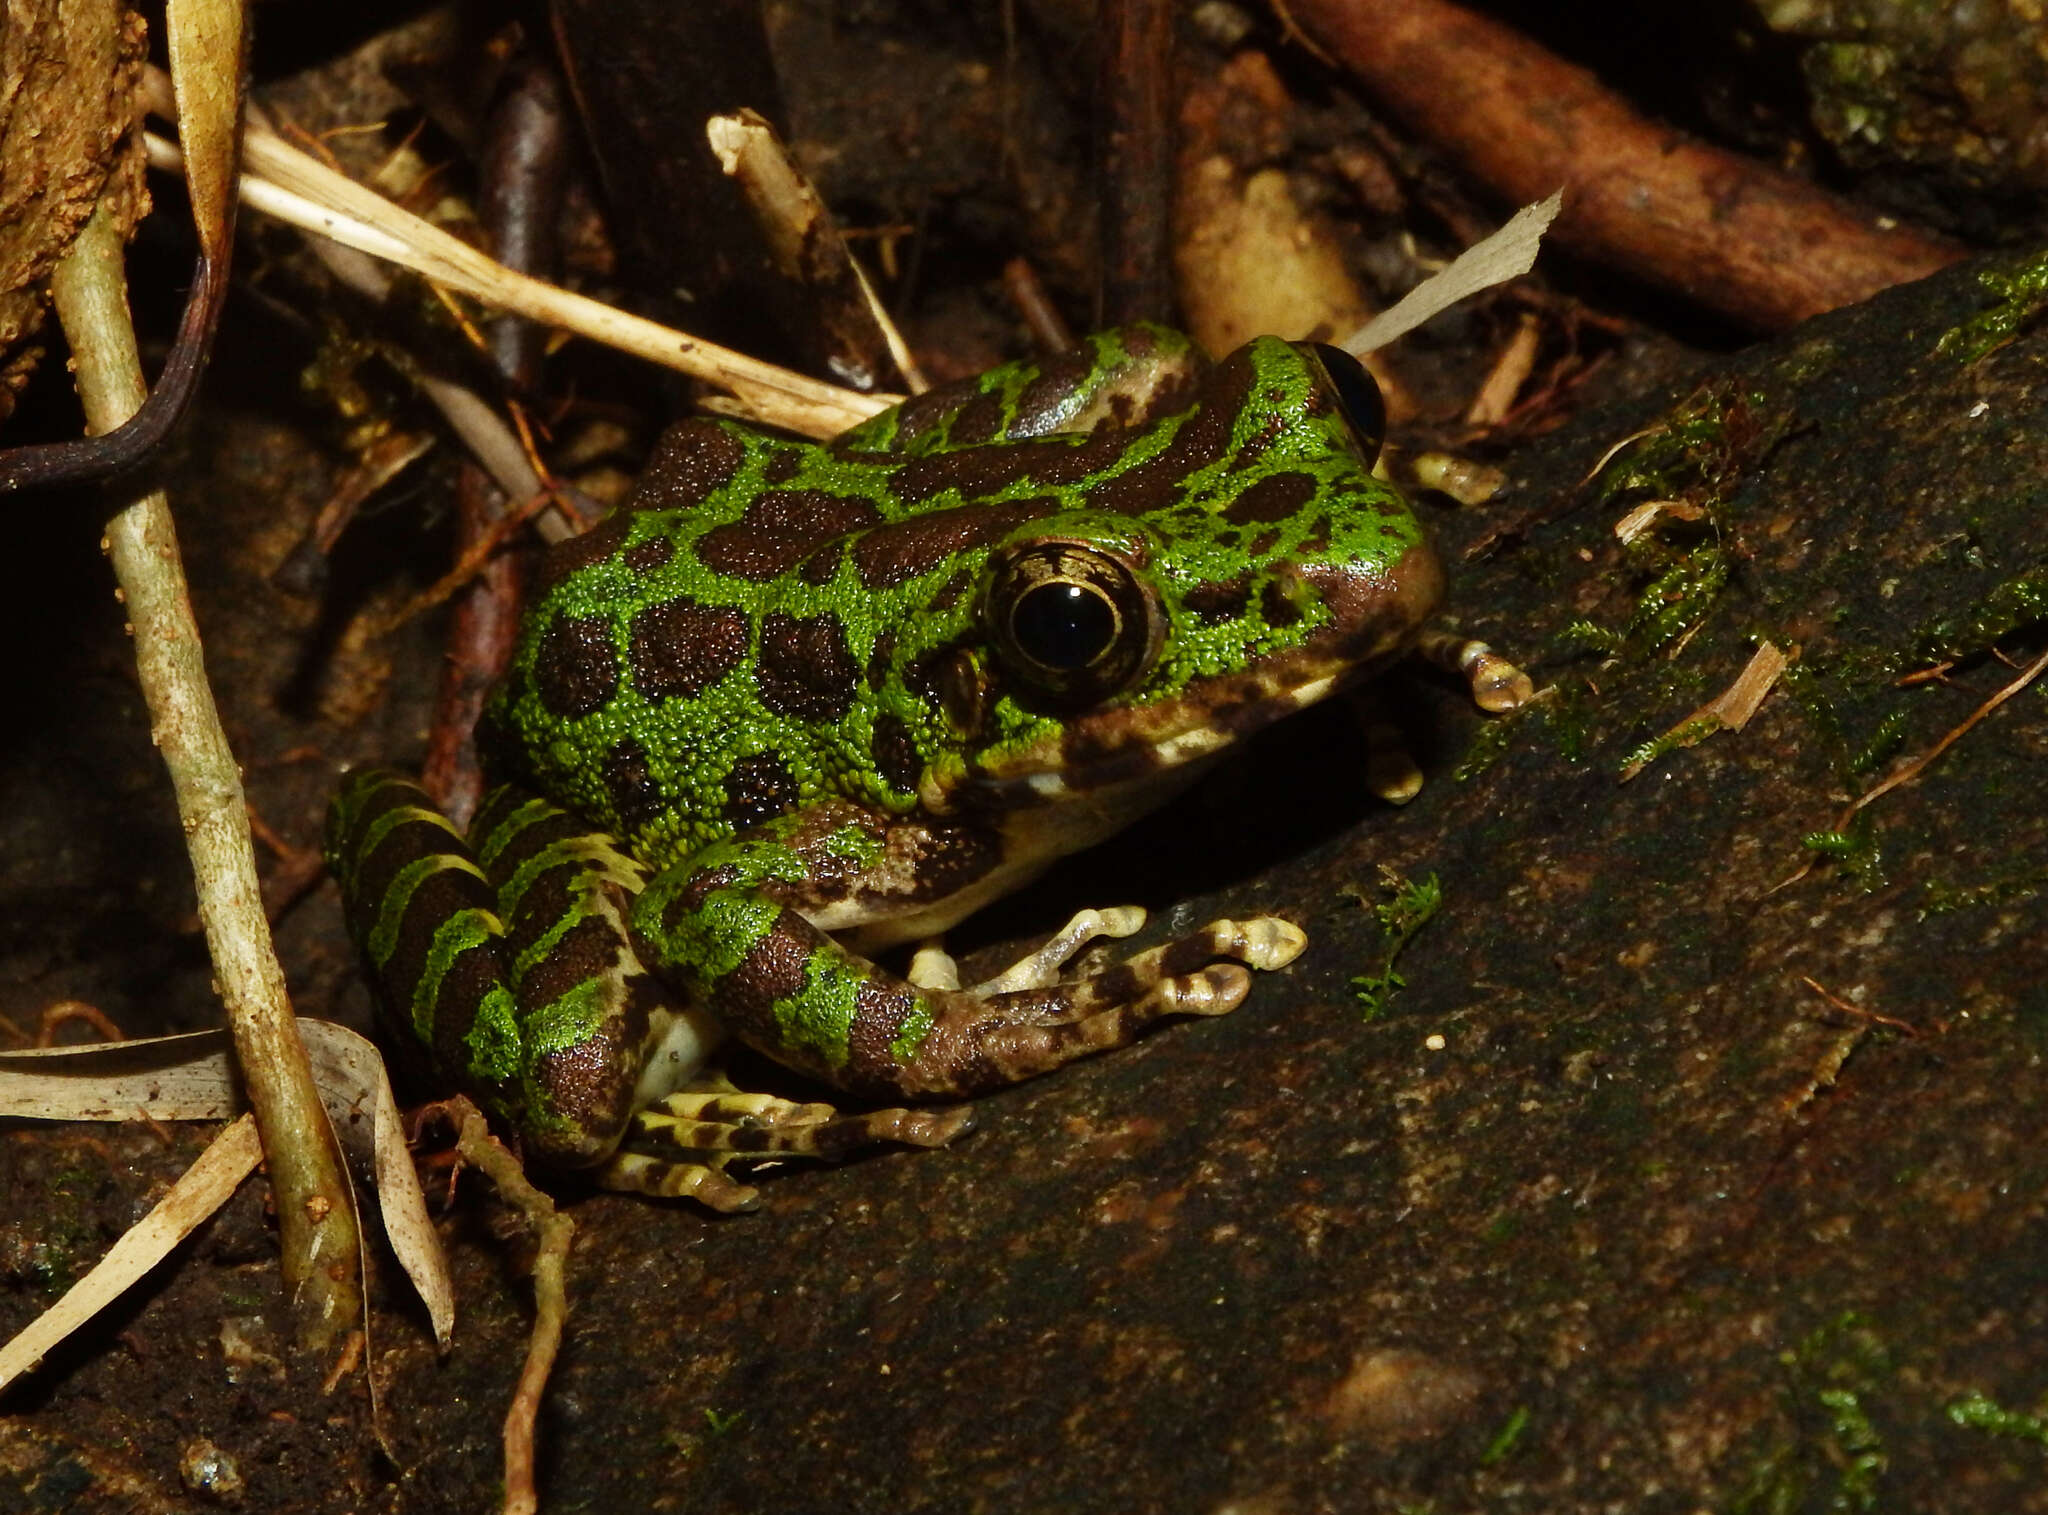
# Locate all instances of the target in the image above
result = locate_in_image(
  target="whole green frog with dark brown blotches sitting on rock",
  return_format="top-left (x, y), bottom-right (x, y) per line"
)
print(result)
top-left (328, 328), bottom-right (1442, 1210)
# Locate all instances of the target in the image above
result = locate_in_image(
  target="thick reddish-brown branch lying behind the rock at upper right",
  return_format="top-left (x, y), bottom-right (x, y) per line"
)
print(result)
top-left (1290, 0), bottom-right (1962, 332)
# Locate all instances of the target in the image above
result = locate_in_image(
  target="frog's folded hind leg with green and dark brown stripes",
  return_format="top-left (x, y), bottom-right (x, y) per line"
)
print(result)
top-left (328, 770), bottom-right (969, 1210)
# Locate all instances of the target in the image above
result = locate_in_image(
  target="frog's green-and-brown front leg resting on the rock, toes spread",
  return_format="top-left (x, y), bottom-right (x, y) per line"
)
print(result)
top-left (633, 803), bottom-right (1305, 1099)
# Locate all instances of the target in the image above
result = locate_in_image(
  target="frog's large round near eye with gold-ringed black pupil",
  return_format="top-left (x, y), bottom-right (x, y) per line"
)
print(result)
top-left (983, 540), bottom-right (1165, 702)
